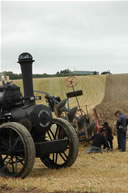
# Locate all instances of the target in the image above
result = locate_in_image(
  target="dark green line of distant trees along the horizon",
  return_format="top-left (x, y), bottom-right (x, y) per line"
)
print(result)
top-left (0, 69), bottom-right (99, 80)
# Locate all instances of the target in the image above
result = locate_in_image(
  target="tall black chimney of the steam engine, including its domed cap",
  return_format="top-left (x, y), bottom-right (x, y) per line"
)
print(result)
top-left (18, 52), bottom-right (34, 103)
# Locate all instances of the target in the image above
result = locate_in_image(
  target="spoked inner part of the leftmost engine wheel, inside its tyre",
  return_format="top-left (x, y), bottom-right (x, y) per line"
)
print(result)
top-left (0, 127), bottom-right (27, 177)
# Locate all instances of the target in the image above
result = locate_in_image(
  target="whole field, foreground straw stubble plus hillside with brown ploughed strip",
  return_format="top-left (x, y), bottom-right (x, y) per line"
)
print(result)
top-left (0, 74), bottom-right (128, 193)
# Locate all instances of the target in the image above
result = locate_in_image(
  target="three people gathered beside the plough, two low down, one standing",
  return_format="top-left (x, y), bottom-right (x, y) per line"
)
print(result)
top-left (87, 110), bottom-right (128, 153)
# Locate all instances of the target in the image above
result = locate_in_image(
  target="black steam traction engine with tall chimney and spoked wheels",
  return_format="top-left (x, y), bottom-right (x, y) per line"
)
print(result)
top-left (0, 53), bottom-right (78, 178)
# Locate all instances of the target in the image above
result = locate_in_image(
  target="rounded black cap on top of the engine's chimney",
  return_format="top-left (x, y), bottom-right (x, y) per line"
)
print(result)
top-left (18, 52), bottom-right (34, 63)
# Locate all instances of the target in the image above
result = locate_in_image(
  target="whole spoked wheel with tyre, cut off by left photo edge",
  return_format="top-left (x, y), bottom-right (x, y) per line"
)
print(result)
top-left (0, 122), bottom-right (35, 178)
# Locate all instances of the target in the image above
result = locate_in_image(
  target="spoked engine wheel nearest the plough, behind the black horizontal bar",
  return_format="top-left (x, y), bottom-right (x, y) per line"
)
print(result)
top-left (40, 118), bottom-right (79, 168)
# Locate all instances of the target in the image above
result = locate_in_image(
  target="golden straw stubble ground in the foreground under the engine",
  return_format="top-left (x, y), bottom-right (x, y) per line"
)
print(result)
top-left (0, 137), bottom-right (128, 193)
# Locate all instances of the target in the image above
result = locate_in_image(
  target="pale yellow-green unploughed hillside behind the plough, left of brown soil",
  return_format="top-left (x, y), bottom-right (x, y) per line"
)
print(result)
top-left (14, 75), bottom-right (107, 109)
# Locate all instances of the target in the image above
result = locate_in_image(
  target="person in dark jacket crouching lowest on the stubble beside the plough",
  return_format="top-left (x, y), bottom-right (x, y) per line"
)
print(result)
top-left (87, 133), bottom-right (109, 153)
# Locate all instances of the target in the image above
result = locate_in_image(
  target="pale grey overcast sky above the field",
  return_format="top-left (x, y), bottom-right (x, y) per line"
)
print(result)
top-left (0, 1), bottom-right (128, 74)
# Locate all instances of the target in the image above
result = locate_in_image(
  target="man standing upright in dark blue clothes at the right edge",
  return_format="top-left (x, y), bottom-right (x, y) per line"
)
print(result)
top-left (115, 110), bottom-right (127, 152)
